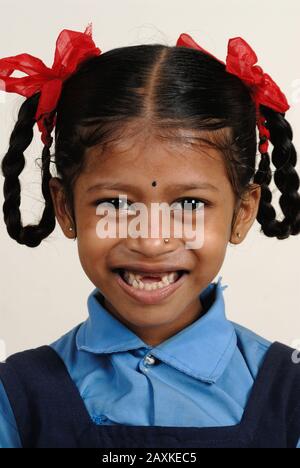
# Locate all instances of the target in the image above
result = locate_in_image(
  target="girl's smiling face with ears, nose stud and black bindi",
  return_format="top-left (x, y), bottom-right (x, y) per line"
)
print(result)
top-left (50, 128), bottom-right (260, 346)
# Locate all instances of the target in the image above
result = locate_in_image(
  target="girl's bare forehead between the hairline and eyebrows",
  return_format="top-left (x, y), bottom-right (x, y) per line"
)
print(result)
top-left (80, 130), bottom-right (227, 185)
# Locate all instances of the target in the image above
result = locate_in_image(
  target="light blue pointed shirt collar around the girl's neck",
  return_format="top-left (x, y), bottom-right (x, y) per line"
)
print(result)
top-left (76, 277), bottom-right (237, 383)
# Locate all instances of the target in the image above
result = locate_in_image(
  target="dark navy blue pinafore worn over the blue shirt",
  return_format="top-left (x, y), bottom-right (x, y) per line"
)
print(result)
top-left (0, 342), bottom-right (300, 448)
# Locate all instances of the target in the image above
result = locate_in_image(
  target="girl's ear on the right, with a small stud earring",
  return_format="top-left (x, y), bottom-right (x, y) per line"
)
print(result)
top-left (230, 184), bottom-right (261, 244)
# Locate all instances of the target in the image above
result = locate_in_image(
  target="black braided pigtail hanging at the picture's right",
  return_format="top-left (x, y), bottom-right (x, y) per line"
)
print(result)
top-left (254, 106), bottom-right (300, 239)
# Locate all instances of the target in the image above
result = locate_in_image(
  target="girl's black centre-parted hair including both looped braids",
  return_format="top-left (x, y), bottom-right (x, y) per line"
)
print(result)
top-left (2, 44), bottom-right (300, 247)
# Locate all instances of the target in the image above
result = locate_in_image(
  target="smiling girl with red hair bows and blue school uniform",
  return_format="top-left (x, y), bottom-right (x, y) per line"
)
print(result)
top-left (0, 25), bottom-right (300, 448)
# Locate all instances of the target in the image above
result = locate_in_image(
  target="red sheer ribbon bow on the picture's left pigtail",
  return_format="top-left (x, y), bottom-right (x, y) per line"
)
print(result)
top-left (0, 23), bottom-right (101, 145)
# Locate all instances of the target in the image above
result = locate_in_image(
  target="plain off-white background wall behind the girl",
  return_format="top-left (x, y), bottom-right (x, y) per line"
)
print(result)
top-left (0, 0), bottom-right (300, 354)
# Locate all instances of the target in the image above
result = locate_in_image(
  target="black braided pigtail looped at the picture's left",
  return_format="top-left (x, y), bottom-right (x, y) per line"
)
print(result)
top-left (1, 93), bottom-right (55, 247)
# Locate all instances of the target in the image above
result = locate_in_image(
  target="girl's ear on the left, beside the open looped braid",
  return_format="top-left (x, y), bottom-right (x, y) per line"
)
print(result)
top-left (49, 177), bottom-right (75, 239)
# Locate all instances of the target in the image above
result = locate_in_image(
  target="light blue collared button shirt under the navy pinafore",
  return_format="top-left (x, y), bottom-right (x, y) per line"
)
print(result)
top-left (0, 277), bottom-right (300, 448)
